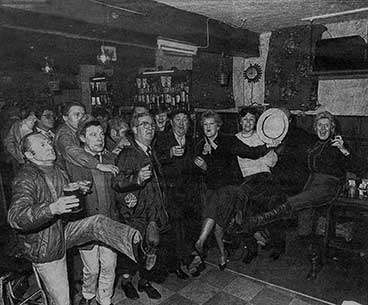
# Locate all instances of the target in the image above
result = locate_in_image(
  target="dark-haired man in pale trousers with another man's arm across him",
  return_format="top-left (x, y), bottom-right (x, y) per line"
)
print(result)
top-left (70, 115), bottom-right (118, 305)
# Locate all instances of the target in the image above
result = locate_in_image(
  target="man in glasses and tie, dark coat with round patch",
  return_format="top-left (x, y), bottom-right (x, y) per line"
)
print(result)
top-left (112, 113), bottom-right (167, 299)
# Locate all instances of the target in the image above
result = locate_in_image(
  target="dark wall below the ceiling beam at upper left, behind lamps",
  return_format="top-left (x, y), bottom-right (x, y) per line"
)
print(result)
top-left (0, 28), bottom-right (155, 104)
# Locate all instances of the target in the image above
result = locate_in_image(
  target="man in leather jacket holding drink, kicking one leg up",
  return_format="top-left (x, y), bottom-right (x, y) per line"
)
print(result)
top-left (8, 133), bottom-right (141, 305)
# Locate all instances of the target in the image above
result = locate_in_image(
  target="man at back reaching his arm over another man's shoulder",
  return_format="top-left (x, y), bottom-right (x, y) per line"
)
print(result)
top-left (55, 102), bottom-right (118, 174)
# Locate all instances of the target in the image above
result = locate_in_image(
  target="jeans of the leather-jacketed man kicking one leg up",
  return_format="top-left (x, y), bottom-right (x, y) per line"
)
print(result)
top-left (33, 215), bottom-right (142, 305)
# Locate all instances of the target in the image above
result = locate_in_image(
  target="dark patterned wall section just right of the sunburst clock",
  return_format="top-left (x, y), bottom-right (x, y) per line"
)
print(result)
top-left (265, 25), bottom-right (326, 110)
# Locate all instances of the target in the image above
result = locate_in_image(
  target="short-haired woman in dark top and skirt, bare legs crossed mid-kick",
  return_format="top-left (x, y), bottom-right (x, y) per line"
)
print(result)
top-left (194, 111), bottom-right (278, 270)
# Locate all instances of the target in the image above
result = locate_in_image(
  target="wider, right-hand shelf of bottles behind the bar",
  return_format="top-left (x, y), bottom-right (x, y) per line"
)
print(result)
top-left (134, 70), bottom-right (191, 111)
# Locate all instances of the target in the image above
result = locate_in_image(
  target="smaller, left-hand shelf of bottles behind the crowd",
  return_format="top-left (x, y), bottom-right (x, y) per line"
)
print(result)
top-left (89, 76), bottom-right (112, 107)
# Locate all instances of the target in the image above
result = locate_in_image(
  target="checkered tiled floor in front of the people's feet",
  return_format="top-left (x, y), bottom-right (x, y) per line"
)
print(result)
top-left (75, 265), bottom-right (331, 305)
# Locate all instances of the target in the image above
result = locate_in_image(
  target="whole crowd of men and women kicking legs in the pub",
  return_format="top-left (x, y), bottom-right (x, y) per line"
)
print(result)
top-left (0, 102), bottom-right (357, 305)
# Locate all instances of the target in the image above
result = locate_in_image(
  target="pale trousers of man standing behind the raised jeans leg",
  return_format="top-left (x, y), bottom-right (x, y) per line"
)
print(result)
top-left (79, 245), bottom-right (117, 305)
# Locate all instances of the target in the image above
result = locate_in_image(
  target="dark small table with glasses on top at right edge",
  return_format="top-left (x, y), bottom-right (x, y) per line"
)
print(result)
top-left (323, 197), bottom-right (368, 257)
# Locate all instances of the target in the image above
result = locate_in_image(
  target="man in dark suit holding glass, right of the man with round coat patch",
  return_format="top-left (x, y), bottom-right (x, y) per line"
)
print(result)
top-left (155, 109), bottom-right (200, 279)
